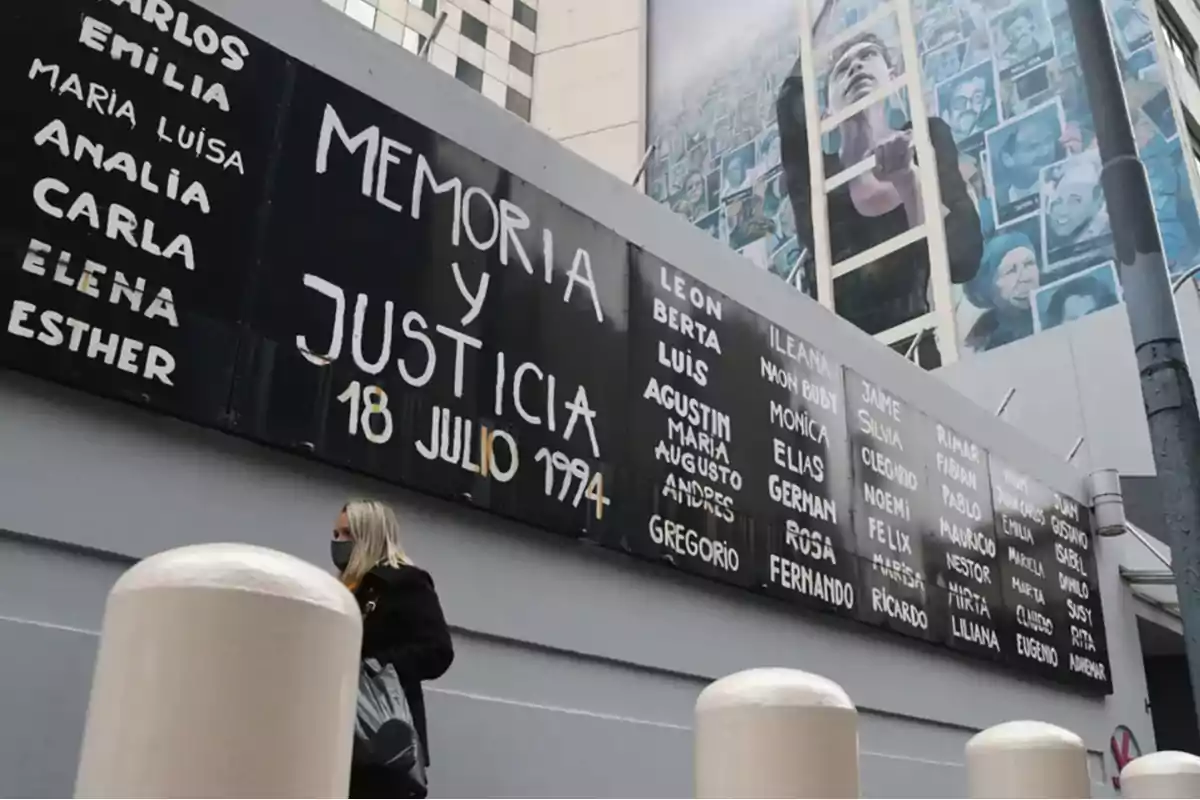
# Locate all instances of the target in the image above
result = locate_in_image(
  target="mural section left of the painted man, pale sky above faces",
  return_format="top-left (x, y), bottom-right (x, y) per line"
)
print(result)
top-left (647, 0), bottom-right (815, 295)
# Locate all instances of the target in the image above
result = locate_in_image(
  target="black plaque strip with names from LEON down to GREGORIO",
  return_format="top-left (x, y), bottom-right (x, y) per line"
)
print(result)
top-left (613, 251), bottom-right (767, 588)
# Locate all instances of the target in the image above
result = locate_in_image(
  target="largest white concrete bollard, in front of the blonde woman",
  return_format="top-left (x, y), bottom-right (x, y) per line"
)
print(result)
top-left (76, 545), bottom-right (362, 798)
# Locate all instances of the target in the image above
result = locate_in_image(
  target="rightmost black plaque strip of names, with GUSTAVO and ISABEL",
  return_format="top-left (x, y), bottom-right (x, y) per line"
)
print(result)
top-left (1049, 492), bottom-right (1112, 693)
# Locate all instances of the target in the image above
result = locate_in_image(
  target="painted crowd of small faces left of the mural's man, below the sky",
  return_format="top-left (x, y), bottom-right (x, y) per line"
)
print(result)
top-left (647, 20), bottom-right (815, 295)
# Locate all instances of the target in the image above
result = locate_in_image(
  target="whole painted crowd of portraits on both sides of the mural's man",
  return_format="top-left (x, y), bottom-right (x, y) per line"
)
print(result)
top-left (647, 0), bottom-right (1200, 362)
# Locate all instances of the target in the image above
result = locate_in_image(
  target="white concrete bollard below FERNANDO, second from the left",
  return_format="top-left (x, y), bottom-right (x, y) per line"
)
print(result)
top-left (695, 669), bottom-right (858, 798)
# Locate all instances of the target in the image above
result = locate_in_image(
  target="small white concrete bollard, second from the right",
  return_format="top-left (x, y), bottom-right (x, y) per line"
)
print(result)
top-left (966, 720), bottom-right (1092, 800)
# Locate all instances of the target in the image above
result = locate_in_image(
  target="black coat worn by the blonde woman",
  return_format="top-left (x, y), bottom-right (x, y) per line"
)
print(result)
top-left (350, 566), bottom-right (454, 796)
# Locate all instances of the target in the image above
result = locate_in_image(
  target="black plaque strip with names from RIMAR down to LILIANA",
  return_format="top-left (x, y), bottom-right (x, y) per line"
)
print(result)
top-left (925, 421), bottom-right (1006, 661)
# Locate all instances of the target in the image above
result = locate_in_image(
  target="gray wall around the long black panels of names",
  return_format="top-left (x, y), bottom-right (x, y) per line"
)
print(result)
top-left (0, 0), bottom-right (1153, 798)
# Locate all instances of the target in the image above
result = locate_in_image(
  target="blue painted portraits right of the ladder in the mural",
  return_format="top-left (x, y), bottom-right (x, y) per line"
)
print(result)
top-left (914, 0), bottom-right (1200, 351)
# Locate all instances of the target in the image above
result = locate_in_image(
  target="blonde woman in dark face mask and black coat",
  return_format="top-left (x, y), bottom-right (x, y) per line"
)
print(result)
top-left (330, 500), bottom-right (454, 798)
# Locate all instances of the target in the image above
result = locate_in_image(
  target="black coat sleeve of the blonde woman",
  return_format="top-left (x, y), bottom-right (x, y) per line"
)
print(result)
top-left (364, 567), bottom-right (454, 682)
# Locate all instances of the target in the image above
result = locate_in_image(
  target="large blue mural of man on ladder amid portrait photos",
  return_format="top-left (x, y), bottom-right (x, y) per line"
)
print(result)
top-left (648, 0), bottom-right (1200, 355)
